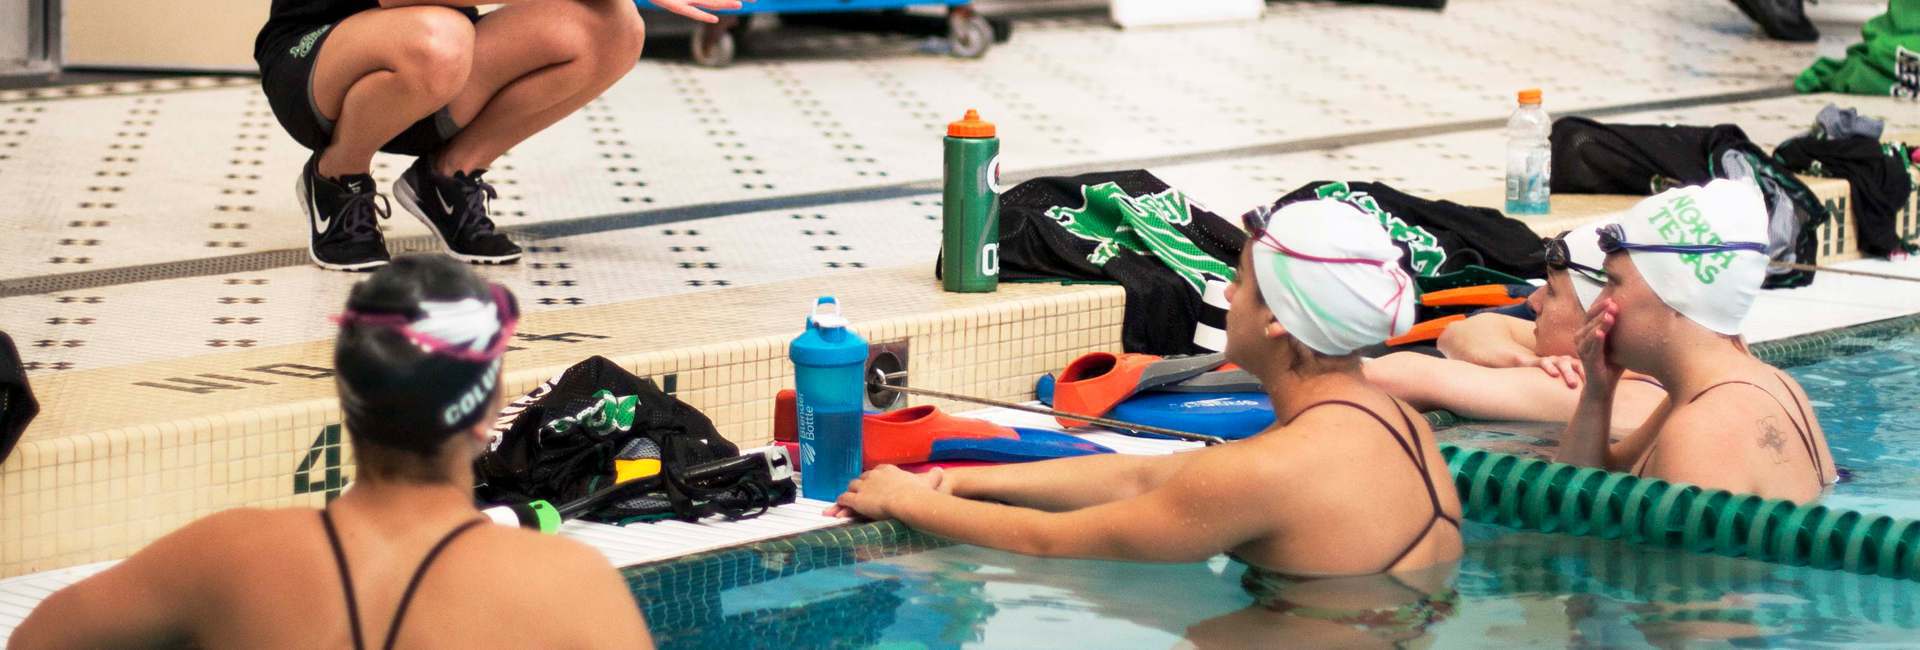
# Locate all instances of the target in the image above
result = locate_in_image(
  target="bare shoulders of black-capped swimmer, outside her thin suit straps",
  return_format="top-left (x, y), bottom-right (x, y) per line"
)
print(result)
top-left (8, 508), bottom-right (653, 648)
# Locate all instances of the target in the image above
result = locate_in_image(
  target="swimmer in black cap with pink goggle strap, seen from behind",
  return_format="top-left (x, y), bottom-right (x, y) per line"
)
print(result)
top-left (10, 257), bottom-right (653, 648)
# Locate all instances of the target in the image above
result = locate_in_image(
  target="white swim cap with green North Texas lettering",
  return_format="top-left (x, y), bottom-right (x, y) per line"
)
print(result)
top-left (1620, 180), bottom-right (1766, 336)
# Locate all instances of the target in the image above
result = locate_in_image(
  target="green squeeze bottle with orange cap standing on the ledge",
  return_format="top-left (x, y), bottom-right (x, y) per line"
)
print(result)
top-left (941, 109), bottom-right (1000, 293)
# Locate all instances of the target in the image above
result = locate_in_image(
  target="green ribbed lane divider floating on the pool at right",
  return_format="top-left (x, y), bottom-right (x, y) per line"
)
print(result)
top-left (1440, 443), bottom-right (1920, 579)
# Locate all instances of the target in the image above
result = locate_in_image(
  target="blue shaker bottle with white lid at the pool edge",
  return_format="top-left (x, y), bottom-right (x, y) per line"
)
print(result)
top-left (787, 295), bottom-right (866, 500)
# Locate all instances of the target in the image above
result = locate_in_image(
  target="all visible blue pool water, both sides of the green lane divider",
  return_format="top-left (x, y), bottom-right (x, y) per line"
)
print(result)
top-left (628, 328), bottom-right (1920, 648)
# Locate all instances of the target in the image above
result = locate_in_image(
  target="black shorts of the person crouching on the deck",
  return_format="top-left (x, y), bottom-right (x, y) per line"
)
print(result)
top-left (259, 13), bottom-right (480, 155)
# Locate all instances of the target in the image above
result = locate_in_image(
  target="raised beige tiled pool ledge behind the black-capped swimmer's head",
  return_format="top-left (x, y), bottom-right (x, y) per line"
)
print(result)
top-left (0, 268), bottom-right (1125, 577)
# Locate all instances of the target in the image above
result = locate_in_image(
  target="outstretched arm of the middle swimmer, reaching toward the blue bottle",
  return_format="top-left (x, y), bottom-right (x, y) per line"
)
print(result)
top-left (839, 447), bottom-right (1284, 562)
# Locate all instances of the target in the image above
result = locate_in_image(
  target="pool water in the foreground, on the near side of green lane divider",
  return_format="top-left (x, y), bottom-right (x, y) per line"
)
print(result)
top-left (636, 522), bottom-right (1920, 648)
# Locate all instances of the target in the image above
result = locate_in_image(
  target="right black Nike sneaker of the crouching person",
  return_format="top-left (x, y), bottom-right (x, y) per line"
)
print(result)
top-left (394, 157), bottom-right (520, 265)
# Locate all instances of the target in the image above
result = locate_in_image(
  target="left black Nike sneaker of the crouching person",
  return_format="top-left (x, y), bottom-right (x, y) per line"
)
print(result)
top-left (294, 153), bottom-right (390, 270)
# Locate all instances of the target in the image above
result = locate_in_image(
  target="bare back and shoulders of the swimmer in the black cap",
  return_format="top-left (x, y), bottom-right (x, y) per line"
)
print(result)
top-left (13, 508), bottom-right (651, 648)
